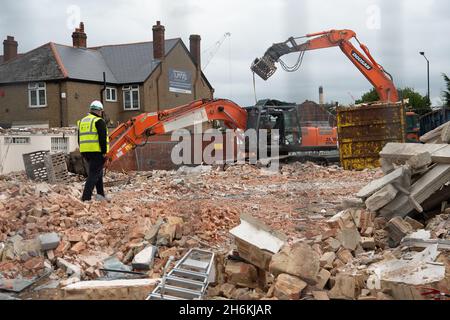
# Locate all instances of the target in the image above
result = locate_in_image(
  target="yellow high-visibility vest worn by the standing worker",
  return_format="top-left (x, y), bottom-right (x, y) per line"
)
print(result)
top-left (78, 114), bottom-right (109, 153)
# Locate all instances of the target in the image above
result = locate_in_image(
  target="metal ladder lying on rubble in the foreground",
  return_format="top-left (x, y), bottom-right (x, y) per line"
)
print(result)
top-left (146, 249), bottom-right (214, 300)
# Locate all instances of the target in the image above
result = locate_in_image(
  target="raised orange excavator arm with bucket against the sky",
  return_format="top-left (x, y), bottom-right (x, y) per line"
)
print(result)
top-left (251, 30), bottom-right (398, 102)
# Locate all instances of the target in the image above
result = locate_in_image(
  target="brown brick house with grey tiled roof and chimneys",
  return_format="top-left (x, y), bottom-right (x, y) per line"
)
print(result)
top-left (0, 21), bottom-right (214, 128)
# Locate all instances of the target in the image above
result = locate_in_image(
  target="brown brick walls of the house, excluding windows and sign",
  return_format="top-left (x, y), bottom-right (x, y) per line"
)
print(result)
top-left (0, 41), bottom-right (213, 127)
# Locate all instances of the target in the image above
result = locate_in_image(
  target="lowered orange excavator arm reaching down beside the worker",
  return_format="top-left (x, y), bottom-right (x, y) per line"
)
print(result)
top-left (106, 99), bottom-right (247, 167)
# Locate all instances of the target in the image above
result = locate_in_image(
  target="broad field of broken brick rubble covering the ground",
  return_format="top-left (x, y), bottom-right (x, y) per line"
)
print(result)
top-left (0, 163), bottom-right (448, 300)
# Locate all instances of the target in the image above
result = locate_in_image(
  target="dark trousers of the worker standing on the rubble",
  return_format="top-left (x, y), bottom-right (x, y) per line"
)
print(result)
top-left (82, 152), bottom-right (105, 201)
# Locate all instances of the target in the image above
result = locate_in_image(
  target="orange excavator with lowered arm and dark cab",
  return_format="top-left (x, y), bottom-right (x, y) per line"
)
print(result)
top-left (106, 99), bottom-right (336, 167)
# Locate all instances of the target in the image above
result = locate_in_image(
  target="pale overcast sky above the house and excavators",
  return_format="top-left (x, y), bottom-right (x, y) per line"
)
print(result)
top-left (0, 0), bottom-right (450, 105)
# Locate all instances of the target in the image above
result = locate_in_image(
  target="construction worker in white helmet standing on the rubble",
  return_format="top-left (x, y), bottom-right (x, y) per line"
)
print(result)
top-left (78, 101), bottom-right (109, 201)
